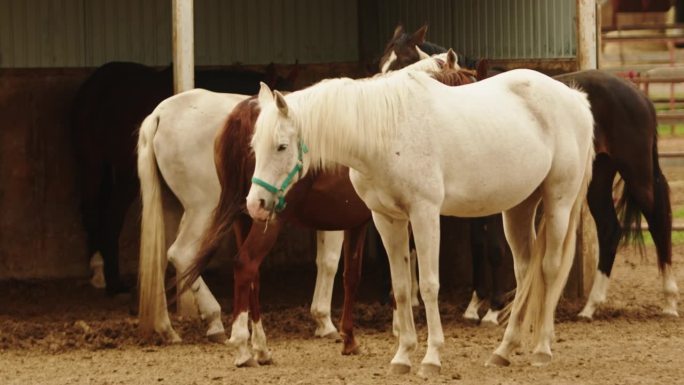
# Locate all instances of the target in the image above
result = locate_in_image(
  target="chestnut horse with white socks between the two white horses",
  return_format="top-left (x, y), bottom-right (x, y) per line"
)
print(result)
top-left (182, 98), bottom-right (370, 366)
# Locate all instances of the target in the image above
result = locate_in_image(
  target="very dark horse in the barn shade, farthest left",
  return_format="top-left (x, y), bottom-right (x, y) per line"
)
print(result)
top-left (72, 62), bottom-right (296, 293)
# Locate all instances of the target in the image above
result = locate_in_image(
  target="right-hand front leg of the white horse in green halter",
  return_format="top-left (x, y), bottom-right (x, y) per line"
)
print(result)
top-left (411, 204), bottom-right (444, 377)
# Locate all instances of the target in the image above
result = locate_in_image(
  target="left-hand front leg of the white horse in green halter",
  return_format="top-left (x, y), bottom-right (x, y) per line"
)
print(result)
top-left (373, 211), bottom-right (417, 374)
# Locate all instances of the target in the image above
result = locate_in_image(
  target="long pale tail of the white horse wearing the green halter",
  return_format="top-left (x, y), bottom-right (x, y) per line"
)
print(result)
top-left (513, 142), bottom-right (594, 341)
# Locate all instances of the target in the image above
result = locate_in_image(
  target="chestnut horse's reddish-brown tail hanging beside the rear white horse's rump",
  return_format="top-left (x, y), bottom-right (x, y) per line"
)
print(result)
top-left (183, 97), bottom-right (259, 289)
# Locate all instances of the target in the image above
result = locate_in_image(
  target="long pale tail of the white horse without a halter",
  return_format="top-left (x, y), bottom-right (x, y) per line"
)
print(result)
top-left (138, 112), bottom-right (166, 334)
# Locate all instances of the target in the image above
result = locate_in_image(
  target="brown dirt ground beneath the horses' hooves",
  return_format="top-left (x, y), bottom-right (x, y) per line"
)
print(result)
top-left (0, 139), bottom-right (684, 385)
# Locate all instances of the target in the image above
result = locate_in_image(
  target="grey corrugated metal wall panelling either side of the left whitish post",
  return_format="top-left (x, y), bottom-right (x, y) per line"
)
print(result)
top-left (0, 0), bottom-right (358, 68)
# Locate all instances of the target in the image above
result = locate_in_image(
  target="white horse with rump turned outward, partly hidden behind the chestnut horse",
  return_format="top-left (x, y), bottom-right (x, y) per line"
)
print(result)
top-left (138, 89), bottom-right (344, 343)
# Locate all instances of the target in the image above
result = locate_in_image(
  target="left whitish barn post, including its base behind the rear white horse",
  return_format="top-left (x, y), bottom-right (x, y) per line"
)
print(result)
top-left (171, 0), bottom-right (199, 318)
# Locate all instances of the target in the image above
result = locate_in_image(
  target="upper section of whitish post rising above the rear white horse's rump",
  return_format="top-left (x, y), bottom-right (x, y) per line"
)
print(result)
top-left (171, 0), bottom-right (195, 93)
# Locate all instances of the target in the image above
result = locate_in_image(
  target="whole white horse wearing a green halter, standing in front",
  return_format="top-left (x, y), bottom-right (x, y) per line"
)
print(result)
top-left (247, 70), bottom-right (593, 375)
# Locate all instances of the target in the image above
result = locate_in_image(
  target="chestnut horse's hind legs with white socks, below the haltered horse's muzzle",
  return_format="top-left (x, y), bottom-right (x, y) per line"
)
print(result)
top-left (228, 218), bottom-right (282, 367)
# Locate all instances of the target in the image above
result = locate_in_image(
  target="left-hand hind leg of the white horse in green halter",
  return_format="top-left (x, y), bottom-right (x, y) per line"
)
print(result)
top-left (486, 192), bottom-right (540, 366)
